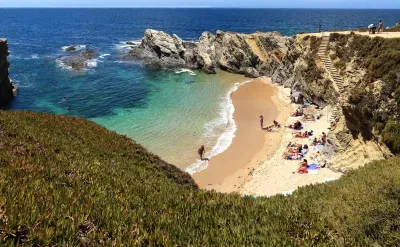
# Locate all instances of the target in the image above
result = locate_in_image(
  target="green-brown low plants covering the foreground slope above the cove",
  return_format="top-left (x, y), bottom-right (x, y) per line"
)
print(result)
top-left (0, 111), bottom-right (400, 246)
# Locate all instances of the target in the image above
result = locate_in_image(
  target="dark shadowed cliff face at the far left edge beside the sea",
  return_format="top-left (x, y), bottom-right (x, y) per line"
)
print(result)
top-left (0, 39), bottom-right (16, 108)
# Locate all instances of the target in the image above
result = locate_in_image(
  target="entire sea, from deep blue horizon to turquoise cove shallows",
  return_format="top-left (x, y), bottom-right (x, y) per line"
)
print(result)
top-left (0, 9), bottom-right (400, 168)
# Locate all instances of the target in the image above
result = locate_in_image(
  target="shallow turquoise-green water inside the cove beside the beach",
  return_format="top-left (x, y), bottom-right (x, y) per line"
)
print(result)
top-left (91, 71), bottom-right (244, 168)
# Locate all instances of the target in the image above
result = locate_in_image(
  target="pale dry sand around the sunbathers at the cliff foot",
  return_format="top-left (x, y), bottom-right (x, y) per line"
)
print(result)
top-left (240, 88), bottom-right (342, 196)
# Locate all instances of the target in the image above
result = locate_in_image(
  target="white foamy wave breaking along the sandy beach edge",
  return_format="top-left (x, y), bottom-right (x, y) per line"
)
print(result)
top-left (185, 80), bottom-right (252, 175)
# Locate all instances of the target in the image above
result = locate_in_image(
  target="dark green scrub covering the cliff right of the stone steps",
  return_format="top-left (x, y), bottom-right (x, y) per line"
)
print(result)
top-left (330, 33), bottom-right (400, 153)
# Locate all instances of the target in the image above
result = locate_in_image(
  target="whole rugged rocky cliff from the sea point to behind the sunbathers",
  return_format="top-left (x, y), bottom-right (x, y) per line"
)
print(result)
top-left (124, 30), bottom-right (400, 170)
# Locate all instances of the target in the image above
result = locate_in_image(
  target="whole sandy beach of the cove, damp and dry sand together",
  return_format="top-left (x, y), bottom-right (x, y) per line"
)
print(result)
top-left (193, 77), bottom-right (342, 196)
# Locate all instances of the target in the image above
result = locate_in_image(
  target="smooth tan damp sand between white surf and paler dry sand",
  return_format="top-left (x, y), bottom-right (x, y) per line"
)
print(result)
top-left (193, 78), bottom-right (291, 192)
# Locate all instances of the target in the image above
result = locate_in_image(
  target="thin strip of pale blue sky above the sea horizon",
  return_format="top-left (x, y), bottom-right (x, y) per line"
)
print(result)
top-left (0, 0), bottom-right (400, 9)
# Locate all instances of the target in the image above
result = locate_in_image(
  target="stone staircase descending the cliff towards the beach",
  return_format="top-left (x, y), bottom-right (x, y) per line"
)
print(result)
top-left (317, 36), bottom-right (344, 122)
